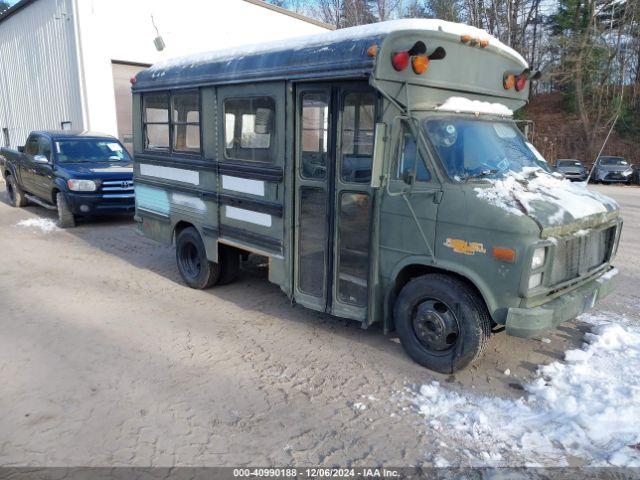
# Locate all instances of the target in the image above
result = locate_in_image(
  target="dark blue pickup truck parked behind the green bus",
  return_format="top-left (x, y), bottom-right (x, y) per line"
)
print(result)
top-left (0, 131), bottom-right (135, 228)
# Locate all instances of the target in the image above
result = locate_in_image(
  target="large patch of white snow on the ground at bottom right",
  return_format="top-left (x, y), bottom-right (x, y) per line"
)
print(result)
top-left (413, 318), bottom-right (640, 467)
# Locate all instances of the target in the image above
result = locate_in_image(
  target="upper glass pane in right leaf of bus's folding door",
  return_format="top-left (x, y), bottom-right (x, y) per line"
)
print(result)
top-left (340, 92), bottom-right (376, 183)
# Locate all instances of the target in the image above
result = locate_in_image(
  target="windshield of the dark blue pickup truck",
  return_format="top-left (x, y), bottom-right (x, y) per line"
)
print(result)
top-left (54, 138), bottom-right (131, 163)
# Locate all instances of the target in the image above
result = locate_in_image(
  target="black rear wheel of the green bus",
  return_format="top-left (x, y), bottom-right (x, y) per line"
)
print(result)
top-left (176, 227), bottom-right (221, 290)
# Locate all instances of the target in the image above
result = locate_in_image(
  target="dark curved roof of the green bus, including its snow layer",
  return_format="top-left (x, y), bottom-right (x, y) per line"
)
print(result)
top-left (133, 19), bottom-right (527, 91)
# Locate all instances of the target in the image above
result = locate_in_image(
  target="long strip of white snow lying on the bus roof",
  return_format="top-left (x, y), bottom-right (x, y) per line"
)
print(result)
top-left (149, 18), bottom-right (528, 73)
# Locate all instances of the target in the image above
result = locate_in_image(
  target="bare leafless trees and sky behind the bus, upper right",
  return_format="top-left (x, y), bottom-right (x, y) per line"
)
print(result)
top-left (271, 0), bottom-right (640, 163)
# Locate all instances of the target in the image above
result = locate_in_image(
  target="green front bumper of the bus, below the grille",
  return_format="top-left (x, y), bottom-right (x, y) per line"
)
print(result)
top-left (506, 267), bottom-right (619, 338)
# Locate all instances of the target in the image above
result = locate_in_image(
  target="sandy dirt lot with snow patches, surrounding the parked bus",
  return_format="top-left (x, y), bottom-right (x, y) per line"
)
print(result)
top-left (0, 185), bottom-right (640, 466)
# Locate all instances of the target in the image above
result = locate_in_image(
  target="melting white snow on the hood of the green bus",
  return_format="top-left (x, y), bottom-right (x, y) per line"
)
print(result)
top-left (474, 167), bottom-right (617, 224)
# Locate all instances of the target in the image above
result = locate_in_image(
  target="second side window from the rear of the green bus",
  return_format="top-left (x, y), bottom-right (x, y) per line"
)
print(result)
top-left (171, 92), bottom-right (200, 153)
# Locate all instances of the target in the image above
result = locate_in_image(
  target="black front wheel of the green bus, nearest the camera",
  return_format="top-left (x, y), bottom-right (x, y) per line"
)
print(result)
top-left (394, 274), bottom-right (491, 373)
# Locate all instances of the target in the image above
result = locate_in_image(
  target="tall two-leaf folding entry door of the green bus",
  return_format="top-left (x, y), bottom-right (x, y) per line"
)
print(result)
top-left (294, 83), bottom-right (377, 320)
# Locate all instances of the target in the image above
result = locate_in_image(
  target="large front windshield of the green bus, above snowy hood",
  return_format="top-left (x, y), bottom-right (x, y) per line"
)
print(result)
top-left (422, 117), bottom-right (549, 181)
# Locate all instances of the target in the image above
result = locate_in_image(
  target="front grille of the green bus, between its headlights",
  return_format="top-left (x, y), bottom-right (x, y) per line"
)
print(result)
top-left (550, 227), bottom-right (616, 285)
